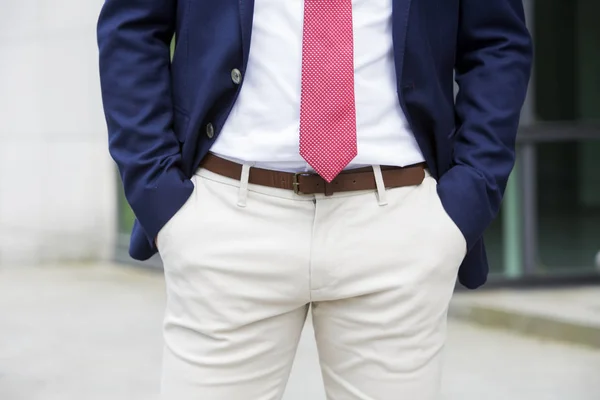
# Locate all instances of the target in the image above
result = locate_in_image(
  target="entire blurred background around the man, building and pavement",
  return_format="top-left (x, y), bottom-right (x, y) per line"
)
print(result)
top-left (0, 0), bottom-right (600, 400)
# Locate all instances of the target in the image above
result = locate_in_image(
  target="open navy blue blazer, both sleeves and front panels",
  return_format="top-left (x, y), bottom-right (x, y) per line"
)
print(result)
top-left (98, 0), bottom-right (532, 288)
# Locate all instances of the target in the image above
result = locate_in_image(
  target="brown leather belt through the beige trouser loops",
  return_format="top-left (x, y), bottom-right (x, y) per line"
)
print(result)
top-left (200, 153), bottom-right (426, 196)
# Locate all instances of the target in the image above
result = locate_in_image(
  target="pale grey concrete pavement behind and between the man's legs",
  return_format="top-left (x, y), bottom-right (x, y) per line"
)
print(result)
top-left (0, 265), bottom-right (600, 400)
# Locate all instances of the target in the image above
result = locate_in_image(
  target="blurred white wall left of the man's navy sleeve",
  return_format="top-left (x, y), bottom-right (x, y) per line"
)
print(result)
top-left (0, 0), bottom-right (117, 265)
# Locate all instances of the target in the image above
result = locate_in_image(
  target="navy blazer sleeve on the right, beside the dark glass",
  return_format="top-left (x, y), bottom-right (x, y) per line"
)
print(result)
top-left (438, 0), bottom-right (532, 249)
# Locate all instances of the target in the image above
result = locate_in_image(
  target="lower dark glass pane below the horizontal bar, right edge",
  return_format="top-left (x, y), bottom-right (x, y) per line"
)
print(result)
top-left (537, 140), bottom-right (600, 270)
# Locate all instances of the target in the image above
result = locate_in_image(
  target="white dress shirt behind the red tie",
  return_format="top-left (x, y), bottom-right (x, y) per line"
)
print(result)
top-left (211, 0), bottom-right (424, 172)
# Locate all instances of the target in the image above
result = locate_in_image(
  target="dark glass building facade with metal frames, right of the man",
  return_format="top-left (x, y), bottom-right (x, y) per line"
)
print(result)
top-left (487, 0), bottom-right (600, 281)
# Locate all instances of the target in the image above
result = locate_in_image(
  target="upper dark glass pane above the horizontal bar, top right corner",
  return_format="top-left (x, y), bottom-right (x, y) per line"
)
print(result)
top-left (533, 0), bottom-right (600, 121)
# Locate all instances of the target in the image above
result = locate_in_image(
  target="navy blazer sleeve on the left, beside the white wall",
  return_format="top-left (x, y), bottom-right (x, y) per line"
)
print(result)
top-left (97, 0), bottom-right (193, 249)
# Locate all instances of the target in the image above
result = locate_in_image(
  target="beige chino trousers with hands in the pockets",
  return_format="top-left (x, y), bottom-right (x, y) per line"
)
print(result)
top-left (158, 166), bottom-right (466, 400)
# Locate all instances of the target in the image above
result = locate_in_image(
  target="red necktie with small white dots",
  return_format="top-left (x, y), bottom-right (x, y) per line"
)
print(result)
top-left (300, 0), bottom-right (357, 182)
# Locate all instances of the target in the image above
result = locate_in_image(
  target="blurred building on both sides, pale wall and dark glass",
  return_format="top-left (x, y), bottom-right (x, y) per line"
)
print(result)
top-left (0, 0), bottom-right (600, 281)
